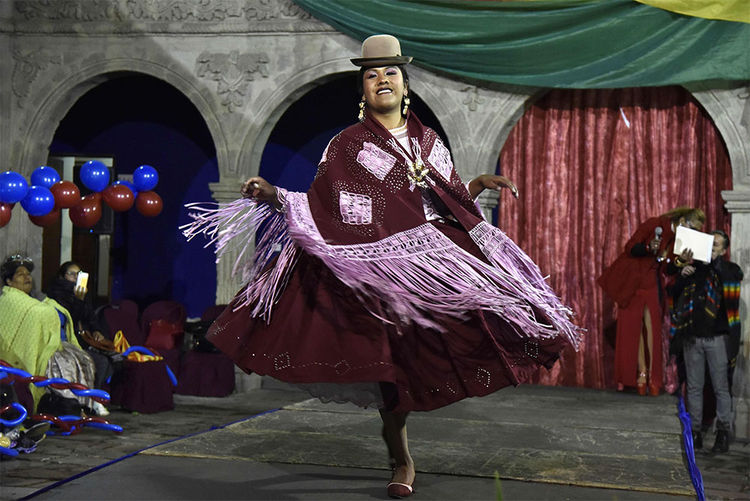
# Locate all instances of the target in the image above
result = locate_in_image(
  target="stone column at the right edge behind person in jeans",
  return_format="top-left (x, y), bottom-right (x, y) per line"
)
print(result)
top-left (722, 187), bottom-right (750, 439)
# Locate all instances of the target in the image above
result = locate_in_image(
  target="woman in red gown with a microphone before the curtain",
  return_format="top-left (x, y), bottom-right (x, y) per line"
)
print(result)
top-left (598, 207), bottom-right (706, 396)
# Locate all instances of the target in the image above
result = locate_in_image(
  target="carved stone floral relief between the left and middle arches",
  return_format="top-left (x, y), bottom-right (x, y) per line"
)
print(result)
top-left (196, 50), bottom-right (269, 113)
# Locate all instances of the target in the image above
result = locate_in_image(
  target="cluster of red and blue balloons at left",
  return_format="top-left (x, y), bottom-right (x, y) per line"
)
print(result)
top-left (0, 160), bottom-right (163, 228)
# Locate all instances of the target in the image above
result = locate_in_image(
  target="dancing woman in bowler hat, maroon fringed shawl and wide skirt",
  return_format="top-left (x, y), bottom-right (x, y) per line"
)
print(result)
top-left (185, 35), bottom-right (580, 497)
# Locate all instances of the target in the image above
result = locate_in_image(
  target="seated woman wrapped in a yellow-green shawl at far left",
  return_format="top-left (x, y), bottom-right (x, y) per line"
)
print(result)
top-left (0, 255), bottom-right (106, 414)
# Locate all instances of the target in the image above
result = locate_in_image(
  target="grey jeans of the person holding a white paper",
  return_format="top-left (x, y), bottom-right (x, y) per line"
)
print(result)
top-left (684, 336), bottom-right (732, 431)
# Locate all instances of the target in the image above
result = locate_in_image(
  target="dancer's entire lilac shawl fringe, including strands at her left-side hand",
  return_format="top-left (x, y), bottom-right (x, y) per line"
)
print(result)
top-left (180, 193), bottom-right (581, 348)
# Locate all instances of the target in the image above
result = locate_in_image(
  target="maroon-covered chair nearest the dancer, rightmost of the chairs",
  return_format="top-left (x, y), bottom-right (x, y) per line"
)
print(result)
top-left (177, 305), bottom-right (234, 397)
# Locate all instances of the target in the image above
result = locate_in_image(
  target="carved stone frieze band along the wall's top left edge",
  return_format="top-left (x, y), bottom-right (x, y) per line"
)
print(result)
top-left (15, 0), bottom-right (312, 22)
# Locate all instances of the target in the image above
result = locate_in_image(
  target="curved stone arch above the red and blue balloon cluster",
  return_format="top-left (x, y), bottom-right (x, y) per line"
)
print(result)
top-left (18, 58), bottom-right (227, 178)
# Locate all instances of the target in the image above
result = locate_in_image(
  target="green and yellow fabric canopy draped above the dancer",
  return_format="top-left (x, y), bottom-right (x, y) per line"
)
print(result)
top-left (295, 0), bottom-right (750, 89)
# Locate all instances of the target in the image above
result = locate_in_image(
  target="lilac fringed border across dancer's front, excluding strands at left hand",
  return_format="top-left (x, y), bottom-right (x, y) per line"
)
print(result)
top-left (287, 193), bottom-right (580, 346)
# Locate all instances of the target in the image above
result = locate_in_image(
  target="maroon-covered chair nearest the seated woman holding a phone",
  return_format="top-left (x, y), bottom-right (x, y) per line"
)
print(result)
top-left (102, 300), bottom-right (174, 414)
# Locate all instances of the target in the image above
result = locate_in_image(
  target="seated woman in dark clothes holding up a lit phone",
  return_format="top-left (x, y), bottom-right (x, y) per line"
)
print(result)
top-left (46, 261), bottom-right (116, 394)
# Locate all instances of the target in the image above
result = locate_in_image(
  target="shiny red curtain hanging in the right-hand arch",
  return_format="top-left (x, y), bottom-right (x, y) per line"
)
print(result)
top-left (498, 87), bottom-right (732, 388)
